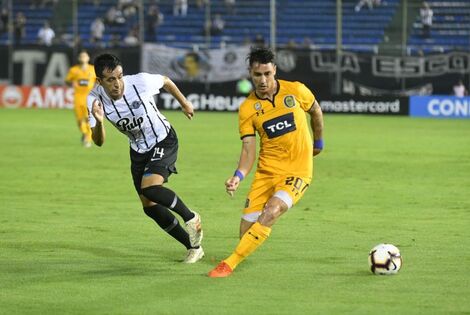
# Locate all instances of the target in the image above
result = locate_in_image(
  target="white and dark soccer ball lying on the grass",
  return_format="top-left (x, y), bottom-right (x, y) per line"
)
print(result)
top-left (369, 244), bottom-right (402, 275)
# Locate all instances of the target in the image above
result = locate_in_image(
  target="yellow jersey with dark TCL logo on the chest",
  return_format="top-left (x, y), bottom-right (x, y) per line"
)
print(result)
top-left (238, 80), bottom-right (315, 180)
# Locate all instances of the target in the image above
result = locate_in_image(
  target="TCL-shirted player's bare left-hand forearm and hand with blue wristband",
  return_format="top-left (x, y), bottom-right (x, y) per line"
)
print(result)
top-left (225, 136), bottom-right (256, 196)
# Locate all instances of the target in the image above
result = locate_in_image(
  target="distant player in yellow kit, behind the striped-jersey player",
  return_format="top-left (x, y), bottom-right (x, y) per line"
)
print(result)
top-left (65, 50), bottom-right (96, 148)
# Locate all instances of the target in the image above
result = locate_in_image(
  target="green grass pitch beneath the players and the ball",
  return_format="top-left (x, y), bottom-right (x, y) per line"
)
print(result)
top-left (0, 109), bottom-right (470, 314)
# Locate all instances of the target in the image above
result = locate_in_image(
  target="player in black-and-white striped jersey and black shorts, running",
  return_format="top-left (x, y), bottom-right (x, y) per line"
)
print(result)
top-left (87, 54), bottom-right (204, 263)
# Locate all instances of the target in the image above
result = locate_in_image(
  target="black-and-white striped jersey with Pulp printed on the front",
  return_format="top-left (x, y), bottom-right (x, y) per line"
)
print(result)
top-left (87, 72), bottom-right (171, 153)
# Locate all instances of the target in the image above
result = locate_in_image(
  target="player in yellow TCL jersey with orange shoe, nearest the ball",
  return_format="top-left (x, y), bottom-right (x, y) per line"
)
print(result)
top-left (209, 48), bottom-right (323, 278)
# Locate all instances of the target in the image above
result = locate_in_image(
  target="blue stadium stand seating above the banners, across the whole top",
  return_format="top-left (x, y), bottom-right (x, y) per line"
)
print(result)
top-left (0, 0), bottom-right (470, 53)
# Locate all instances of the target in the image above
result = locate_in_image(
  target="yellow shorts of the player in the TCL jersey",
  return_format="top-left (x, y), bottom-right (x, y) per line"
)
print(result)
top-left (242, 174), bottom-right (311, 222)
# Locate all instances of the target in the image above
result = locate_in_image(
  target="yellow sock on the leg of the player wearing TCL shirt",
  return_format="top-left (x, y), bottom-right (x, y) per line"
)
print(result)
top-left (224, 222), bottom-right (271, 270)
